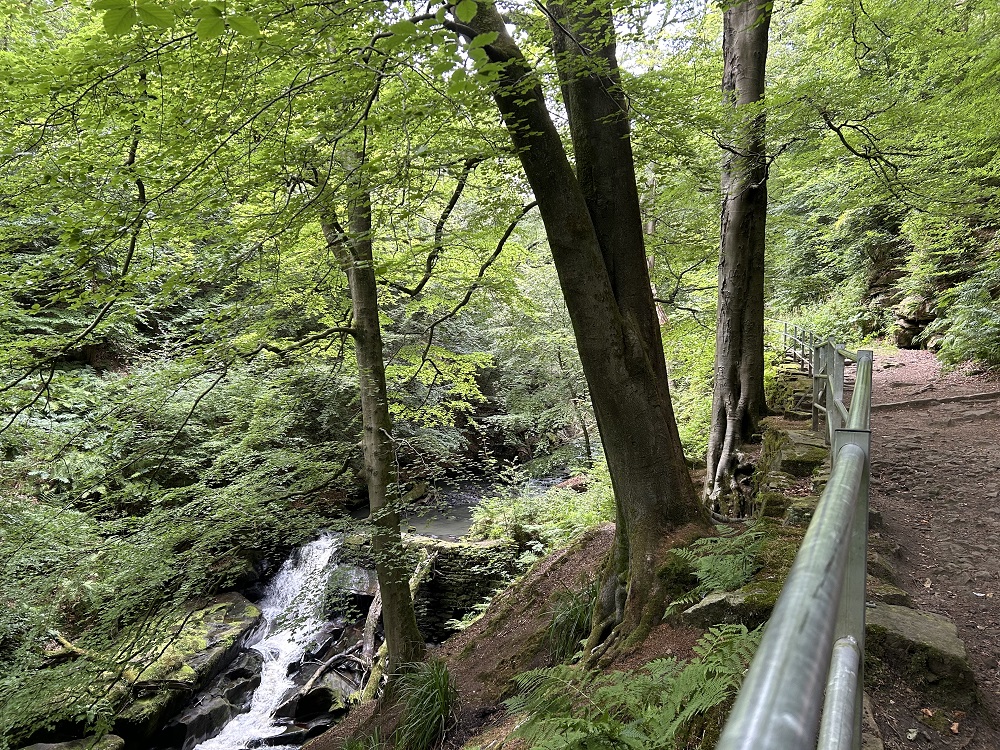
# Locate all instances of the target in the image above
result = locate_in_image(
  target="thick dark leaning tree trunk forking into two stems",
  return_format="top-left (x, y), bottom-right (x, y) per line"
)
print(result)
top-left (462, 2), bottom-right (705, 653)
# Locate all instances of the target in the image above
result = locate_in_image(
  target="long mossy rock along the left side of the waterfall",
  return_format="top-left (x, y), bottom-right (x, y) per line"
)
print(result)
top-left (114, 593), bottom-right (260, 746)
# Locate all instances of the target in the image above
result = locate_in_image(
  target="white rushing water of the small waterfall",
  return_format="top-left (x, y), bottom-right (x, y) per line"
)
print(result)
top-left (194, 536), bottom-right (340, 750)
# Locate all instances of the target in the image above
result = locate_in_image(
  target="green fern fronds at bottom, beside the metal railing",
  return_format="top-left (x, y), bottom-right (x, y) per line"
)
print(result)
top-left (507, 625), bottom-right (760, 750)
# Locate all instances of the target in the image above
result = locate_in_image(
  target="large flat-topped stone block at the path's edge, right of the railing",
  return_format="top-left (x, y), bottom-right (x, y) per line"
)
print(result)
top-left (865, 603), bottom-right (976, 708)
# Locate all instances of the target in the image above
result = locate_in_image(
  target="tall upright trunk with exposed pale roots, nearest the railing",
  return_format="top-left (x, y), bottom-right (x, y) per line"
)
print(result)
top-left (705, 0), bottom-right (771, 516)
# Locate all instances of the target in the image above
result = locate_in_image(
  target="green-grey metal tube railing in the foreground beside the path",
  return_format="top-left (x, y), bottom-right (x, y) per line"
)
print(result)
top-left (716, 331), bottom-right (872, 750)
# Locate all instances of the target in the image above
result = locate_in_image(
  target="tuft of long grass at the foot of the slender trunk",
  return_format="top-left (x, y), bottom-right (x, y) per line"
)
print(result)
top-left (393, 660), bottom-right (458, 750)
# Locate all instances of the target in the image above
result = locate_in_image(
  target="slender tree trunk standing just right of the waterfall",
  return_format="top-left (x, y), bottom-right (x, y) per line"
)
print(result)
top-left (322, 189), bottom-right (424, 674)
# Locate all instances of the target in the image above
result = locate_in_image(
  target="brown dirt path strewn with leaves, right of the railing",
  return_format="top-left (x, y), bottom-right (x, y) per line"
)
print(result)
top-left (872, 351), bottom-right (1000, 750)
